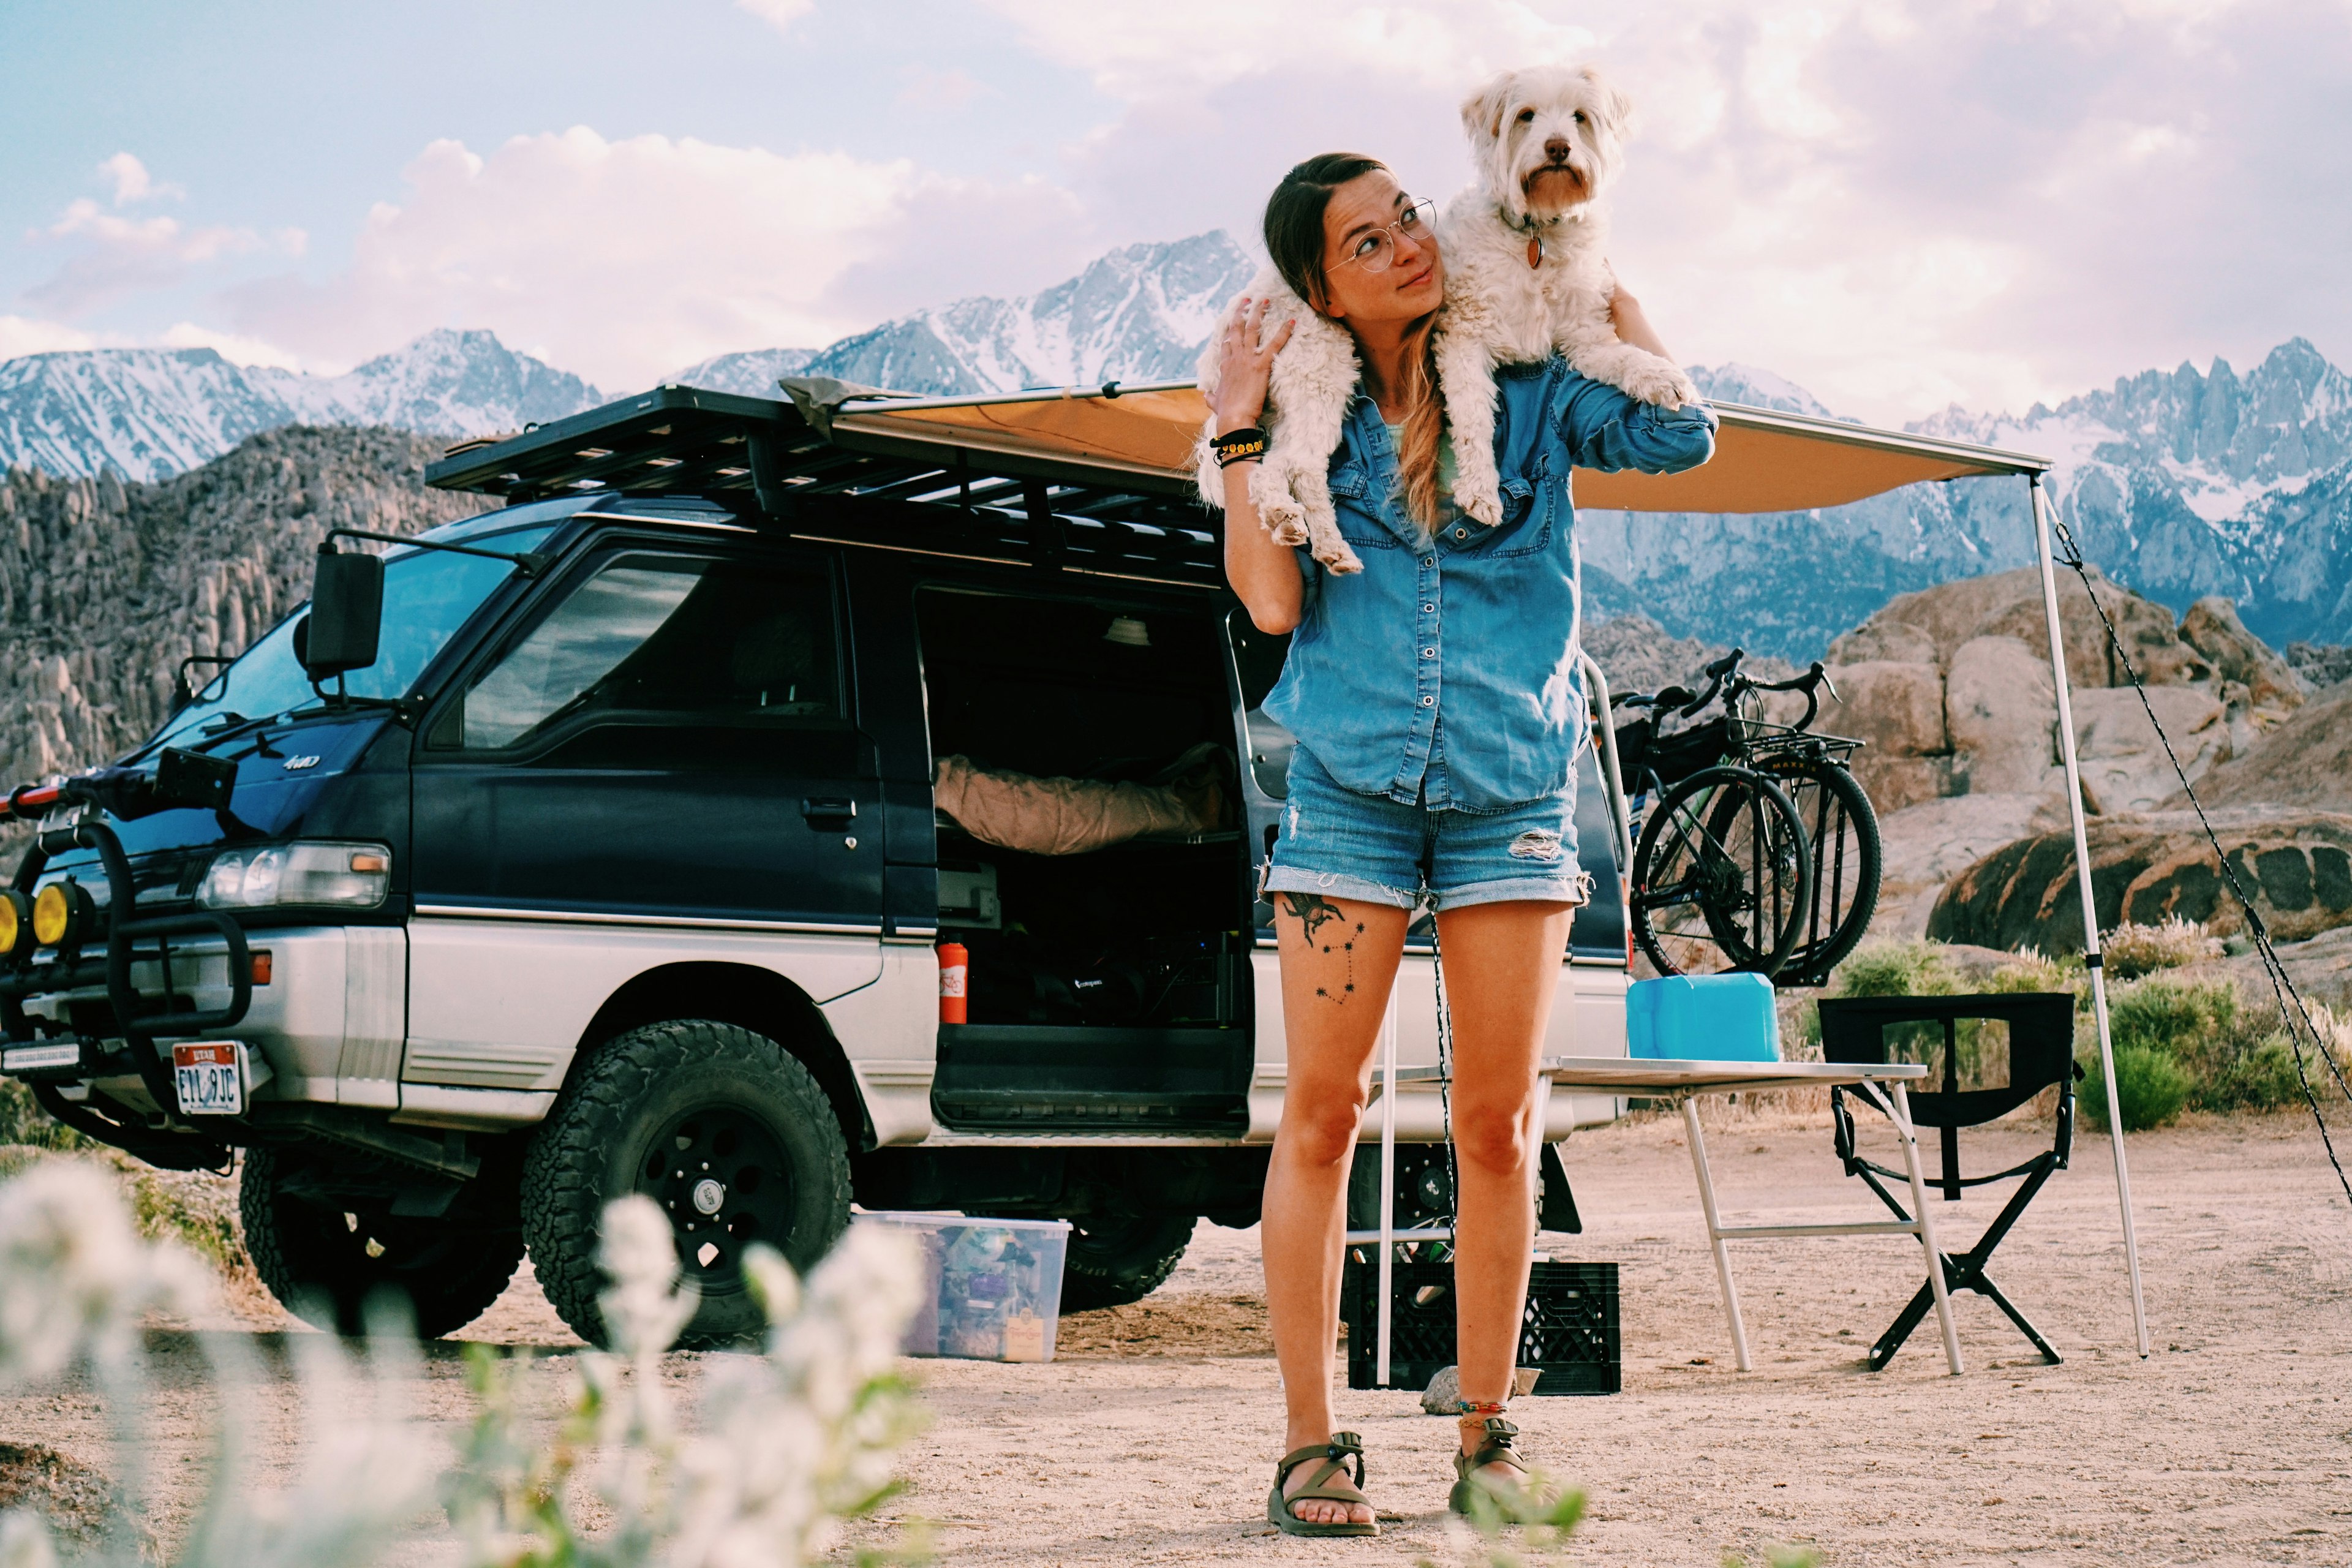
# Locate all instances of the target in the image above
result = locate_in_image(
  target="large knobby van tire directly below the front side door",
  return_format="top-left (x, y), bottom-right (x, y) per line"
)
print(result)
top-left (522, 1018), bottom-right (849, 1347)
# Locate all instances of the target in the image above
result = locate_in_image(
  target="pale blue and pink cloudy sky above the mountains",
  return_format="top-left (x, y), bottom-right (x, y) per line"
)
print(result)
top-left (0, 0), bottom-right (2352, 421)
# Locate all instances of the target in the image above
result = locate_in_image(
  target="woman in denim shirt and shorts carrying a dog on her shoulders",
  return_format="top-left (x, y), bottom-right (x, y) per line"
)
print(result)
top-left (1213, 153), bottom-right (1714, 1535)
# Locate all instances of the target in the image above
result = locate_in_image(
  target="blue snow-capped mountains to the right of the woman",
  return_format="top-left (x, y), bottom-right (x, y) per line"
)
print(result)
top-left (1580, 339), bottom-right (2352, 661)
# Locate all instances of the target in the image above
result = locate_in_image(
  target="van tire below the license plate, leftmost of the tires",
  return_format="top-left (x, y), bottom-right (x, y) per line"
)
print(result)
top-left (238, 1145), bottom-right (522, 1340)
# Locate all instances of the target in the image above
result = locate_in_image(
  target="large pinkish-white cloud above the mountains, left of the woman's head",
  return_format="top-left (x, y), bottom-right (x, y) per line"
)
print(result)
top-left (228, 127), bottom-right (1091, 388)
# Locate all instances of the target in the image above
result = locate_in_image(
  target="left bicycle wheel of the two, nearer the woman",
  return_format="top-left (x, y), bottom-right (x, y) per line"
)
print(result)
top-left (1630, 766), bottom-right (1814, 978)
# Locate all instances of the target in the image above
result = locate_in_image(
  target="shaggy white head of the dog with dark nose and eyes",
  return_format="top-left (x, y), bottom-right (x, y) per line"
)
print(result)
top-left (1463, 66), bottom-right (1632, 221)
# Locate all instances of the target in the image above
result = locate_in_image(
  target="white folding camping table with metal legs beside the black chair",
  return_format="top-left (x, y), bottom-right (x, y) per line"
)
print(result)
top-left (1348, 1053), bottom-right (1962, 1387)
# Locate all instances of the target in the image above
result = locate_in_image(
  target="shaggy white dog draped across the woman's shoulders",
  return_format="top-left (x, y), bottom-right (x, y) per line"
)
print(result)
top-left (1199, 66), bottom-right (1698, 573)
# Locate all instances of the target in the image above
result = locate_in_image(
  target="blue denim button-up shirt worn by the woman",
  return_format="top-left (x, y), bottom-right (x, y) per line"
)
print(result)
top-left (1265, 357), bottom-right (1714, 813)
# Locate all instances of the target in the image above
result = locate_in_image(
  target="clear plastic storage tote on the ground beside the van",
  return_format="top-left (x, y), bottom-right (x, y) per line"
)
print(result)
top-left (856, 1213), bottom-right (1070, 1361)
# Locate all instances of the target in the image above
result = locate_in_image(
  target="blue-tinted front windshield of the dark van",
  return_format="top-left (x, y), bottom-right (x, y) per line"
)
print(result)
top-left (148, 529), bottom-right (552, 748)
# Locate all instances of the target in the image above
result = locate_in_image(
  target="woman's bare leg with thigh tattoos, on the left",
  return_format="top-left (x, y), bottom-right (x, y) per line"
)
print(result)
top-left (1261, 893), bottom-right (1406, 1523)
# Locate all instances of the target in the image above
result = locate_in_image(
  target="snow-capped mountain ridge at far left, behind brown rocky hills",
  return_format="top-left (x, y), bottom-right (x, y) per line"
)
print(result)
top-left (0, 331), bottom-right (605, 480)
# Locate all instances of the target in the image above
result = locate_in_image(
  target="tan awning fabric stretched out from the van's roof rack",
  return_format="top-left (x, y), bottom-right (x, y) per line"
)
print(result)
top-left (832, 383), bottom-right (2049, 513)
